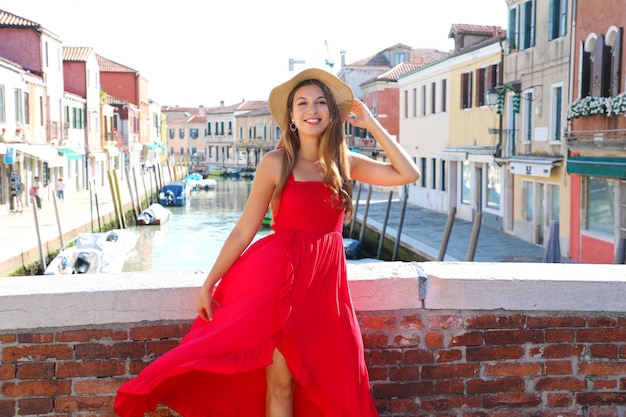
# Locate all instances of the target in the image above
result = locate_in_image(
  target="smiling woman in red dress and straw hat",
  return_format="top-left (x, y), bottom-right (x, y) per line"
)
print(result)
top-left (115, 69), bottom-right (420, 417)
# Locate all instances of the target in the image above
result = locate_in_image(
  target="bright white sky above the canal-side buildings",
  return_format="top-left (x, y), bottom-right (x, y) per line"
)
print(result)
top-left (0, 0), bottom-right (507, 107)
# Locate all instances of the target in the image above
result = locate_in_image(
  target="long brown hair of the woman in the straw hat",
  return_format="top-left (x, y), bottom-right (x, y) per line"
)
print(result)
top-left (272, 79), bottom-right (354, 221)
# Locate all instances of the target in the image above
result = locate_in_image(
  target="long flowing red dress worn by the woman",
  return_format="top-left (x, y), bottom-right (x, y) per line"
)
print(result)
top-left (115, 176), bottom-right (378, 417)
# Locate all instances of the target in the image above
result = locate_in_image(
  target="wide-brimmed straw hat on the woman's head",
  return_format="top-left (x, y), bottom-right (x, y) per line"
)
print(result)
top-left (267, 68), bottom-right (354, 131)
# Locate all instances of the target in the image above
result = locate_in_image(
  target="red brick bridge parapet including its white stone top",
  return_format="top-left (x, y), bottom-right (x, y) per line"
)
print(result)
top-left (0, 263), bottom-right (626, 417)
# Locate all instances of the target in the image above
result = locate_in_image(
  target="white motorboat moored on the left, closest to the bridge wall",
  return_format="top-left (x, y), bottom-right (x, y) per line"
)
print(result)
top-left (44, 229), bottom-right (139, 275)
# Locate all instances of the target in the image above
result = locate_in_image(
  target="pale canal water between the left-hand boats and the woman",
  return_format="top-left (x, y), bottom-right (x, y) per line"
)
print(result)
top-left (124, 178), bottom-right (271, 271)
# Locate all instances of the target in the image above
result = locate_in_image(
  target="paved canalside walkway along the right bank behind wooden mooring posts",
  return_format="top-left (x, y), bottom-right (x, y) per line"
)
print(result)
top-left (350, 187), bottom-right (567, 262)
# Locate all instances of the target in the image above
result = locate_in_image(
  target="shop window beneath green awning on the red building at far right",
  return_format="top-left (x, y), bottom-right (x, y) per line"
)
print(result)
top-left (585, 177), bottom-right (615, 235)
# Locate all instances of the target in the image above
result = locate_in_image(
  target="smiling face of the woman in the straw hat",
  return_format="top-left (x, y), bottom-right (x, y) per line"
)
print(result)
top-left (290, 84), bottom-right (330, 137)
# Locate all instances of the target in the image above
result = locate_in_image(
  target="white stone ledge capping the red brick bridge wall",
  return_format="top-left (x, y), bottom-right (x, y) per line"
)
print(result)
top-left (0, 262), bottom-right (626, 332)
